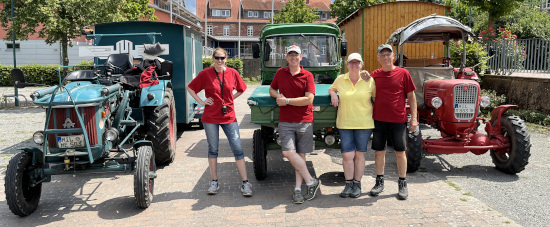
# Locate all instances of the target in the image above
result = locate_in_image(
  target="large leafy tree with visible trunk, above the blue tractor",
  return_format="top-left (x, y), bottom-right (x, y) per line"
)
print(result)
top-left (0, 0), bottom-right (156, 71)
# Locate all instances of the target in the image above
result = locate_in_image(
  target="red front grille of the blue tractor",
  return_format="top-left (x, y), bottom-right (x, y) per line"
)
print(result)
top-left (46, 106), bottom-right (98, 148)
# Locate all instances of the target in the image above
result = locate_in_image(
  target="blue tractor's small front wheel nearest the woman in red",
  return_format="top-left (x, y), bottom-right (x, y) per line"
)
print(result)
top-left (134, 146), bottom-right (157, 208)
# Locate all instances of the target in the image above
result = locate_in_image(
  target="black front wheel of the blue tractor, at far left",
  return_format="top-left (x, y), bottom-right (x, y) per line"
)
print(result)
top-left (4, 152), bottom-right (42, 217)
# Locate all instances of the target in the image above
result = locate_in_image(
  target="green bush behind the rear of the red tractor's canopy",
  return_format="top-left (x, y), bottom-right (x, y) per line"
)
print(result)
top-left (449, 41), bottom-right (489, 75)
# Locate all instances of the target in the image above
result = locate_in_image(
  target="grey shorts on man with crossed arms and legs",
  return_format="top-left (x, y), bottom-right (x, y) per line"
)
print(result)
top-left (279, 122), bottom-right (313, 153)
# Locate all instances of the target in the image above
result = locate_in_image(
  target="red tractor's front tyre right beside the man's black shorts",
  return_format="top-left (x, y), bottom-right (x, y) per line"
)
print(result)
top-left (405, 125), bottom-right (424, 173)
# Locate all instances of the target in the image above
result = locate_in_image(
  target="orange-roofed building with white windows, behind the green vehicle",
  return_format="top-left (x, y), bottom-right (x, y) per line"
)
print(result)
top-left (196, 0), bottom-right (336, 58)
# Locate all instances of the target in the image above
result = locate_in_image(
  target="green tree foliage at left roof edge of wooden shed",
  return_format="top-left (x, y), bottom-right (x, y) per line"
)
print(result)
top-left (330, 0), bottom-right (393, 24)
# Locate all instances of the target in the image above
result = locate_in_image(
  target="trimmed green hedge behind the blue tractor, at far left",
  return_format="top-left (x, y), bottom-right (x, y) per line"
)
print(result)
top-left (0, 61), bottom-right (93, 86)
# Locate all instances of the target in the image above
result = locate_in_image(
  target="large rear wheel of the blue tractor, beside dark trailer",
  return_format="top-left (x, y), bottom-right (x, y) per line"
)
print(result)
top-left (145, 88), bottom-right (178, 164)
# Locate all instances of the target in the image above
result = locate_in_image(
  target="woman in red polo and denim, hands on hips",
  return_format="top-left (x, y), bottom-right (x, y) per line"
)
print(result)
top-left (187, 47), bottom-right (252, 196)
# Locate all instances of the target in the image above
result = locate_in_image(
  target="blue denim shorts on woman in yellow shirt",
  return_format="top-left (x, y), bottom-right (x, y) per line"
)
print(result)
top-left (338, 129), bottom-right (373, 153)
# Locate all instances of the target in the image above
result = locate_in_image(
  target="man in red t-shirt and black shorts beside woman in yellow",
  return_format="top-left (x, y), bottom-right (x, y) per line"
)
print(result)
top-left (370, 44), bottom-right (418, 199)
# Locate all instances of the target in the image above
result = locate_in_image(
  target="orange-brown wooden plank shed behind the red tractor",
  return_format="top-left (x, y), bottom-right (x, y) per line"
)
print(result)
top-left (338, 1), bottom-right (451, 73)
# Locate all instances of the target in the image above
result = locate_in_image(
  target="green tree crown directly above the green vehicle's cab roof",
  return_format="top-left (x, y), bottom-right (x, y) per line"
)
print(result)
top-left (273, 0), bottom-right (320, 24)
